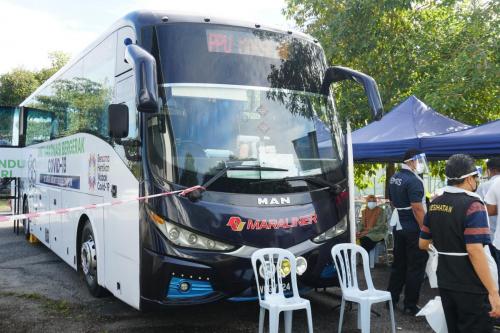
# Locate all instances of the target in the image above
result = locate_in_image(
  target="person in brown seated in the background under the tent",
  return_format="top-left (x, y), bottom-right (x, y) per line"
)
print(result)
top-left (356, 194), bottom-right (387, 252)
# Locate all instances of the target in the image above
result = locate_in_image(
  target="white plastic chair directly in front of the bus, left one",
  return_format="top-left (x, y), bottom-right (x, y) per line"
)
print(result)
top-left (252, 248), bottom-right (313, 333)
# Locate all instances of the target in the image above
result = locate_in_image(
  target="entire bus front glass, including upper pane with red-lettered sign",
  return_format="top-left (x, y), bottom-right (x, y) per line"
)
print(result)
top-left (147, 23), bottom-right (344, 193)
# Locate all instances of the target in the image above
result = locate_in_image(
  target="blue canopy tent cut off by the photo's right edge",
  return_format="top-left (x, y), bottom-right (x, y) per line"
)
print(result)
top-left (421, 120), bottom-right (500, 159)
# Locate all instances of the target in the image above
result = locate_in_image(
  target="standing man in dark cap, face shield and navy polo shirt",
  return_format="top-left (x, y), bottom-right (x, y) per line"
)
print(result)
top-left (387, 149), bottom-right (428, 315)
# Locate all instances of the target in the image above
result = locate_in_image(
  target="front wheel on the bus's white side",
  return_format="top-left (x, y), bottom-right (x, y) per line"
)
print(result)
top-left (80, 220), bottom-right (104, 297)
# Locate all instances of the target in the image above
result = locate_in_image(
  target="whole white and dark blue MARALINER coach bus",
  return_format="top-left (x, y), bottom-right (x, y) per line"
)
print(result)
top-left (10, 11), bottom-right (382, 309)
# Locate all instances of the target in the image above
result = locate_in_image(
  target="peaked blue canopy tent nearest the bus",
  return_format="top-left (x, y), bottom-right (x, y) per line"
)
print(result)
top-left (352, 96), bottom-right (469, 162)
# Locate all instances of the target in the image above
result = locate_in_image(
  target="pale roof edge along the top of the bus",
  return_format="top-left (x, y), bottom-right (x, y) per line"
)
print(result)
top-left (20, 10), bottom-right (317, 106)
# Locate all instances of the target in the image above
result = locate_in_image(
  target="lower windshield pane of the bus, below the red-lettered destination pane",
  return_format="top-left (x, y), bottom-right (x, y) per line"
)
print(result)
top-left (147, 84), bottom-right (342, 193)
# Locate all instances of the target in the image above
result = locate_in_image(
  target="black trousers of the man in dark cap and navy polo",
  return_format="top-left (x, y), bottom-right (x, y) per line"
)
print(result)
top-left (387, 229), bottom-right (428, 307)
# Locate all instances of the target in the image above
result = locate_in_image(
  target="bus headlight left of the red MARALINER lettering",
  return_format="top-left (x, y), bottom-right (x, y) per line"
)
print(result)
top-left (148, 210), bottom-right (235, 251)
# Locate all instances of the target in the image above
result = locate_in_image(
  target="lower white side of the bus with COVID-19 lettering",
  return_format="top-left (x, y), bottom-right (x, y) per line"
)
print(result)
top-left (24, 133), bottom-right (140, 308)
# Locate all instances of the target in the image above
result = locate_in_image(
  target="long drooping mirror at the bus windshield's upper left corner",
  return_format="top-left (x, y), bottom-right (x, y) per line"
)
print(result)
top-left (125, 44), bottom-right (158, 113)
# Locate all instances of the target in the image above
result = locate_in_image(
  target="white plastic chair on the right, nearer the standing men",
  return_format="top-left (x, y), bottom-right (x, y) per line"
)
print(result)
top-left (332, 243), bottom-right (396, 333)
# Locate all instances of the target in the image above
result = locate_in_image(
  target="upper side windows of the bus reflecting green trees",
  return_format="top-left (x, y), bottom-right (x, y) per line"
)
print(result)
top-left (25, 34), bottom-right (116, 144)
